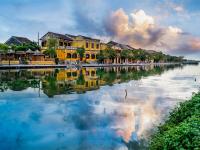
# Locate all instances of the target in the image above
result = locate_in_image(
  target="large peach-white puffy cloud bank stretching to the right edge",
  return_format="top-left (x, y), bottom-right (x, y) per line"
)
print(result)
top-left (105, 8), bottom-right (200, 55)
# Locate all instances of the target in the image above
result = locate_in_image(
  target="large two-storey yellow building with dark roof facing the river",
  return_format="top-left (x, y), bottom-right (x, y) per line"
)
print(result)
top-left (41, 32), bottom-right (101, 63)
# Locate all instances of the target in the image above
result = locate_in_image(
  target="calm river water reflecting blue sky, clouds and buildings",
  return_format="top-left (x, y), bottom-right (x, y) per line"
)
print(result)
top-left (0, 65), bottom-right (200, 150)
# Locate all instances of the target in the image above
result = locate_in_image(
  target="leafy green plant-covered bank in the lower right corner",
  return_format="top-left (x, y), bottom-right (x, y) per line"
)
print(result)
top-left (150, 93), bottom-right (200, 150)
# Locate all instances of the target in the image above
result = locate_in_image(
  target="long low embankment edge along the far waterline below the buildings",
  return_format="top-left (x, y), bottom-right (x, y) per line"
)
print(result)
top-left (0, 63), bottom-right (182, 69)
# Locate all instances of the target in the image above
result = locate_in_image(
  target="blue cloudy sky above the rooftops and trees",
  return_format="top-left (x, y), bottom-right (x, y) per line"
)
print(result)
top-left (0, 0), bottom-right (200, 60)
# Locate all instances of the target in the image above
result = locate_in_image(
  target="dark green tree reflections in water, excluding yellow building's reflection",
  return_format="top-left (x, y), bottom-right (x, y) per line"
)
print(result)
top-left (0, 66), bottom-right (181, 97)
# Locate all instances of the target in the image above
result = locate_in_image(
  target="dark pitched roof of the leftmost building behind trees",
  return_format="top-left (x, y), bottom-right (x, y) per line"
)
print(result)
top-left (5, 36), bottom-right (32, 45)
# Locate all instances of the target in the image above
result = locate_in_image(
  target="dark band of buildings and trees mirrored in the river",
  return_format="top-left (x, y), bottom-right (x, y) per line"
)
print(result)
top-left (0, 66), bottom-right (180, 97)
